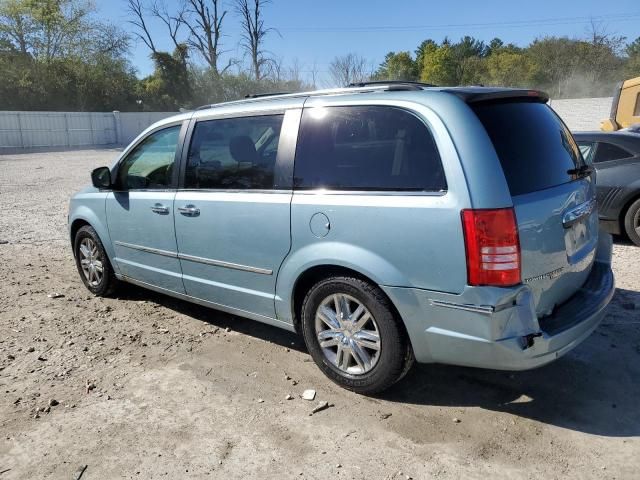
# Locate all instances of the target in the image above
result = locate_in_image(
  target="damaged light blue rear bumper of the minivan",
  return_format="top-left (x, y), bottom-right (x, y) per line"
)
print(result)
top-left (382, 231), bottom-right (615, 370)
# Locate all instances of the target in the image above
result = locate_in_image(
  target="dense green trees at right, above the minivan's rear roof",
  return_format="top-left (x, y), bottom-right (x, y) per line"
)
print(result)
top-left (368, 27), bottom-right (640, 98)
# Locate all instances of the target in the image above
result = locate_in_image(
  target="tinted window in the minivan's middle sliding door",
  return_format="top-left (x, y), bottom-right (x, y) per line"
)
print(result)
top-left (185, 115), bottom-right (284, 189)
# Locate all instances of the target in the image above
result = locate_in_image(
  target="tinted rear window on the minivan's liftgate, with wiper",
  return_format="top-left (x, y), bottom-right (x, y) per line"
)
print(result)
top-left (473, 102), bottom-right (583, 196)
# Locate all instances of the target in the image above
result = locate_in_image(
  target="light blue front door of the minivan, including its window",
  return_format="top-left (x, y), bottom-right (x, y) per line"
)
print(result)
top-left (106, 125), bottom-right (184, 293)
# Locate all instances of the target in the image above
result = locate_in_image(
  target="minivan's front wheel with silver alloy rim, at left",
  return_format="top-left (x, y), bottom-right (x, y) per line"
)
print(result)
top-left (73, 225), bottom-right (118, 297)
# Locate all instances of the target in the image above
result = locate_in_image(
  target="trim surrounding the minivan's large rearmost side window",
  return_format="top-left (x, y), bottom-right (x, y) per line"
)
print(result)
top-left (292, 103), bottom-right (449, 197)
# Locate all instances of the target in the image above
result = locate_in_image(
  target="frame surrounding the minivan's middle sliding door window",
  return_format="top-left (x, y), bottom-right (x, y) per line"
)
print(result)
top-left (177, 107), bottom-right (302, 194)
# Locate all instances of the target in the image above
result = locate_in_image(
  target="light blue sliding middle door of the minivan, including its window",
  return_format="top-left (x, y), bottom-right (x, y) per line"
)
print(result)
top-left (175, 110), bottom-right (299, 318)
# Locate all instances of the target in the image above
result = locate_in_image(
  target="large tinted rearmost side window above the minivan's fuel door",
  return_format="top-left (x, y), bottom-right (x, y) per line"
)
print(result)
top-left (294, 106), bottom-right (447, 191)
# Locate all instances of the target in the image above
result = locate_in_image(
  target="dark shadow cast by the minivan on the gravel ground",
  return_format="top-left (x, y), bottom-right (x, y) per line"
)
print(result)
top-left (120, 287), bottom-right (640, 437)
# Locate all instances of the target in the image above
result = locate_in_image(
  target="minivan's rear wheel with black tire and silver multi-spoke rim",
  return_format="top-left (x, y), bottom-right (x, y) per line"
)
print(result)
top-left (302, 277), bottom-right (412, 394)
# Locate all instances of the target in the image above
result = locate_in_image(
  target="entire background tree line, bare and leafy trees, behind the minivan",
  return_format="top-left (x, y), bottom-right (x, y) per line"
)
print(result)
top-left (0, 0), bottom-right (640, 111)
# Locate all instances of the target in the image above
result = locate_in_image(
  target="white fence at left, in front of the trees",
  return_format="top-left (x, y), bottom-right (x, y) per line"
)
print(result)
top-left (0, 112), bottom-right (175, 153)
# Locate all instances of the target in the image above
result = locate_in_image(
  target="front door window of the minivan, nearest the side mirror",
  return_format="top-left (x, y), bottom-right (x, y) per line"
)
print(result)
top-left (118, 125), bottom-right (180, 190)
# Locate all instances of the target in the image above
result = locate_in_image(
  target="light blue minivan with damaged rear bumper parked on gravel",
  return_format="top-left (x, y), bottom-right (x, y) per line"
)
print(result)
top-left (69, 82), bottom-right (614, 393)
